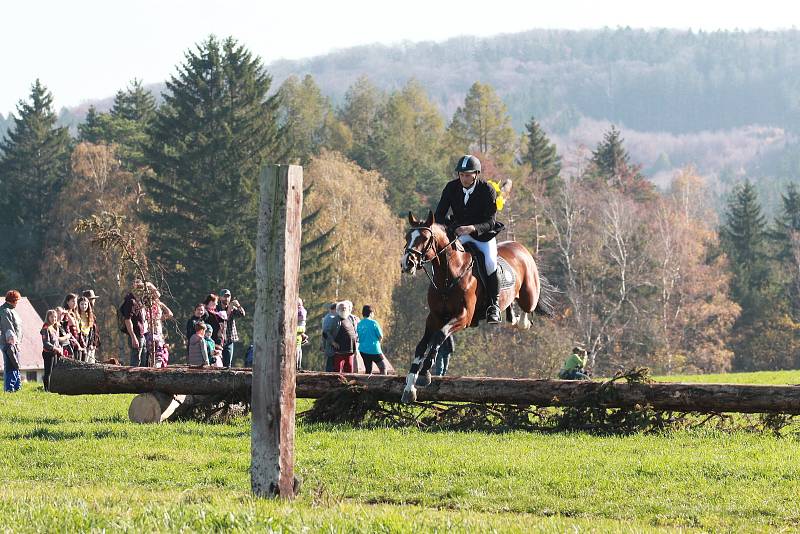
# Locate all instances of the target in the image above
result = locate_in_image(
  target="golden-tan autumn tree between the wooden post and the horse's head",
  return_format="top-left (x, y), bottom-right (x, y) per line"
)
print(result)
top-left (300, 151), bottom-right (403, 368)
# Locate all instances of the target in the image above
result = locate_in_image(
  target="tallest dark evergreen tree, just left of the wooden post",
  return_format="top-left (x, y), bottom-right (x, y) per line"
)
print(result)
top-left (146, 36), bottom-right (282, 309)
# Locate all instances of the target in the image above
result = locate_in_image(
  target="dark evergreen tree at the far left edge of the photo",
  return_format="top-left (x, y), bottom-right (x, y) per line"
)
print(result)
top-left (0, 80), bottom-right (70, 288)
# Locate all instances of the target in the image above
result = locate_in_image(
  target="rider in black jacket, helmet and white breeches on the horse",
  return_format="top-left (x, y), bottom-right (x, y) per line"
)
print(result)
top-left (434, 154), bottom-right (503, 324)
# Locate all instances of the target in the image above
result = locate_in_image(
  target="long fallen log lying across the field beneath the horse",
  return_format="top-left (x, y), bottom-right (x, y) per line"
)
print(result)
top-left (50, 360), bottom-right (800, 414)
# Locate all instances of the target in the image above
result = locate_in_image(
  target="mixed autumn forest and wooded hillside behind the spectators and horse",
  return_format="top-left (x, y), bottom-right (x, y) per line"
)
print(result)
top-left (0, 34), bottom-right (800, 377)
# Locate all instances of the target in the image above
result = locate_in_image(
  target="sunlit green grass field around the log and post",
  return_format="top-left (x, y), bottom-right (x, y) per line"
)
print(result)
top-left (0, 372), bottom-right (800, 532)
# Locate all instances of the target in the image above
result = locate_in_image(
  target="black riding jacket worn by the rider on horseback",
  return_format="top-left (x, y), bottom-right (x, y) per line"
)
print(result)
top-left (434, 178), bottom-right (496, 241)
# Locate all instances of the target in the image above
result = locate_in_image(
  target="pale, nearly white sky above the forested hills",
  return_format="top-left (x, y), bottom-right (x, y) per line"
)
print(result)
top-left (0, 0), bottom-right (800, 115)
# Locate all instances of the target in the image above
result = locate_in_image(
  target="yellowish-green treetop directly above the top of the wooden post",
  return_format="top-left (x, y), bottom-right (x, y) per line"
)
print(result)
top-left (278, 75), bottom-right (352, 164)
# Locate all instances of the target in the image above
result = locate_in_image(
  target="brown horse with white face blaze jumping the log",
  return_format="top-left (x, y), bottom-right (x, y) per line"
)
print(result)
top-left (400, 211), bottom-right (555, 403)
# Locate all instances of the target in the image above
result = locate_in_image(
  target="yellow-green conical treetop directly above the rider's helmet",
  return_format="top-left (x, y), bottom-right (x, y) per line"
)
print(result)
top-left (448, 82), bottom-right (516, 168)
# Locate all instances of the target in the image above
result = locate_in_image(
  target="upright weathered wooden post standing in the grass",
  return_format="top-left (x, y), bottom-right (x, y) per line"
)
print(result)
top-left (250, 165), bottom-right (303, 499)
